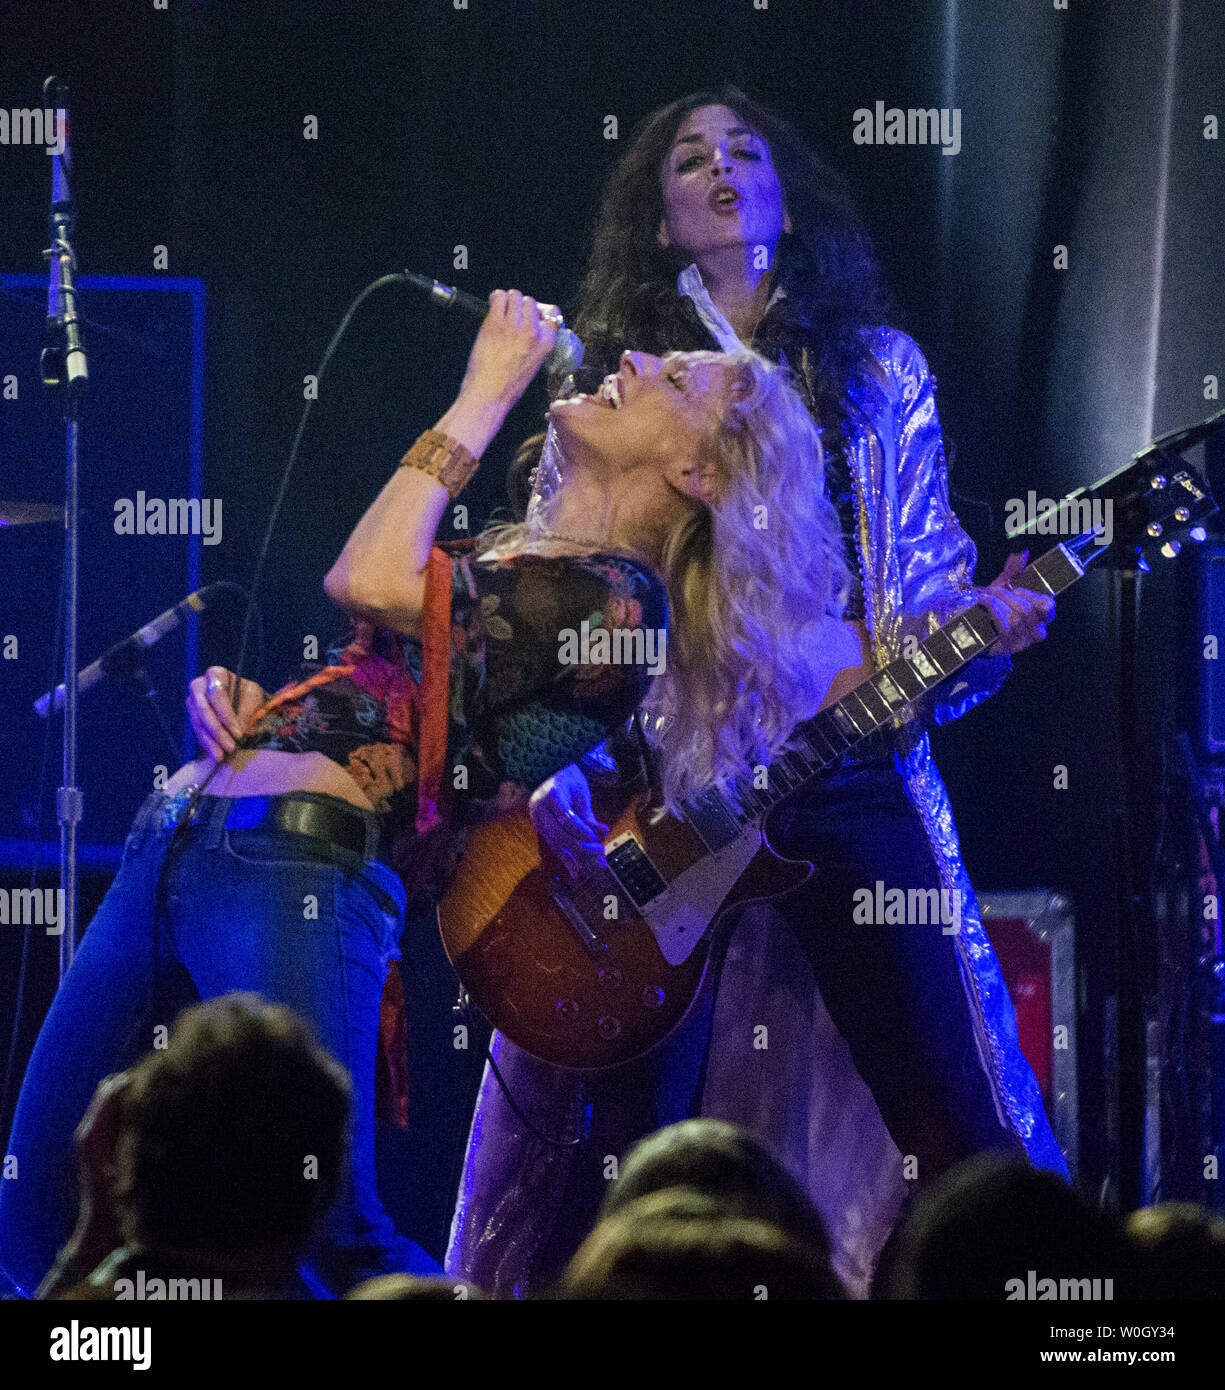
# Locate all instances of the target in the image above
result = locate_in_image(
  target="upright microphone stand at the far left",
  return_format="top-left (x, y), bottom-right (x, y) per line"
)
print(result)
top-left (40, 78), bottom-right (89, 983)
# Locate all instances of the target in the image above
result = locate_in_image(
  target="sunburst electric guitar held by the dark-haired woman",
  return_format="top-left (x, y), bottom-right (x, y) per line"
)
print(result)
top-left (438, 459), bottom-right (1215, 1070)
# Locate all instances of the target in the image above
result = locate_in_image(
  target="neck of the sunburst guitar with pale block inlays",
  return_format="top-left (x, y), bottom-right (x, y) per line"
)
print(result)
top-left (685, 545), bottom-right (1085, 849)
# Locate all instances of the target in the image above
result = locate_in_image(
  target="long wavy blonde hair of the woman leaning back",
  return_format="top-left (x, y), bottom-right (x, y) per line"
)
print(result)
top-left (487, 349), bottom-right (847, 812)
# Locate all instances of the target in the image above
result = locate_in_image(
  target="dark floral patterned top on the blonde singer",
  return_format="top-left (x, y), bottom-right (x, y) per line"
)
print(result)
top-left (234, 542), bottom-right (667, 900)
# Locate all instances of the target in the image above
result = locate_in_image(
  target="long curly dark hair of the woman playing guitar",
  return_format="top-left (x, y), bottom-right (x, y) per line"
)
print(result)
top-left (510, 86), bottom-right (895, 505)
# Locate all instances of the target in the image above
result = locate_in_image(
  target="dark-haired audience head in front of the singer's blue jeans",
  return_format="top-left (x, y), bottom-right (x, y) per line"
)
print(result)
top-left (115, 994), bottom-right (350, 1282)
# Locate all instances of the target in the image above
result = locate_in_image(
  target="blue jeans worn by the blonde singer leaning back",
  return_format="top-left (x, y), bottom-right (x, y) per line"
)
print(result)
top-left (0, 792), bottom-right (439, 1295)
